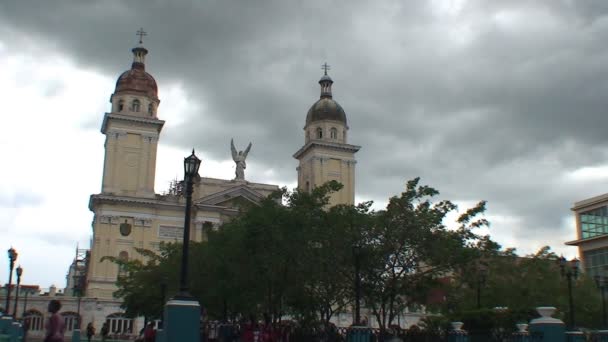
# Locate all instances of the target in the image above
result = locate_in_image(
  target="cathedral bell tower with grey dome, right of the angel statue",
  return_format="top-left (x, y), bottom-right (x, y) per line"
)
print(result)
top-left (293, 63), bottom-right (361, 205)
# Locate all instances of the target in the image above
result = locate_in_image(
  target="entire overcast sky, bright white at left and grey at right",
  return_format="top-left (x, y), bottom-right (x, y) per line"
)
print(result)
top-left (0, 0), bottom-right (608, 288)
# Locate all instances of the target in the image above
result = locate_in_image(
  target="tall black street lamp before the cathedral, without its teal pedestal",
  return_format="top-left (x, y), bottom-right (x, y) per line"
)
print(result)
top-left (179, 150), bottom-right (201, 298)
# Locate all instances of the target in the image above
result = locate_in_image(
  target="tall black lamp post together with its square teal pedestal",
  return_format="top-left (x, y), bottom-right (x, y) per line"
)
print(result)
top-left (163, 150), bottom-right (201, 342)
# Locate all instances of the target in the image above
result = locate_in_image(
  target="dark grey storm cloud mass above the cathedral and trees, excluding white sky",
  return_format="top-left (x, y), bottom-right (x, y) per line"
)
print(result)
top-left (0, 0), bottom-right (608, 251)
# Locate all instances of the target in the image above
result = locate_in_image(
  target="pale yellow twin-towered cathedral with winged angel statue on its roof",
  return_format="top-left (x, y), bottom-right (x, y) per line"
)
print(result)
top-left (0, 32), bottom-right (360, 336)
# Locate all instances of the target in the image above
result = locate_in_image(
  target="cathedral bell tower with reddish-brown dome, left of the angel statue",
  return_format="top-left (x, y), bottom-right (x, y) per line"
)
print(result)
top-left (101, 30), bottom-right (165, 198)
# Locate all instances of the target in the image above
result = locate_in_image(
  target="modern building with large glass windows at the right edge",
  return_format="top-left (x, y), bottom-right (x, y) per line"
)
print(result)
top-left (566, 194), bottom-right (608, 277)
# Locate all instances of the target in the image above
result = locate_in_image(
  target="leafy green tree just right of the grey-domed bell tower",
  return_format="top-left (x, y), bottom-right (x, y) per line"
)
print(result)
top-left (356, 178), bottom-right (487, 329)
